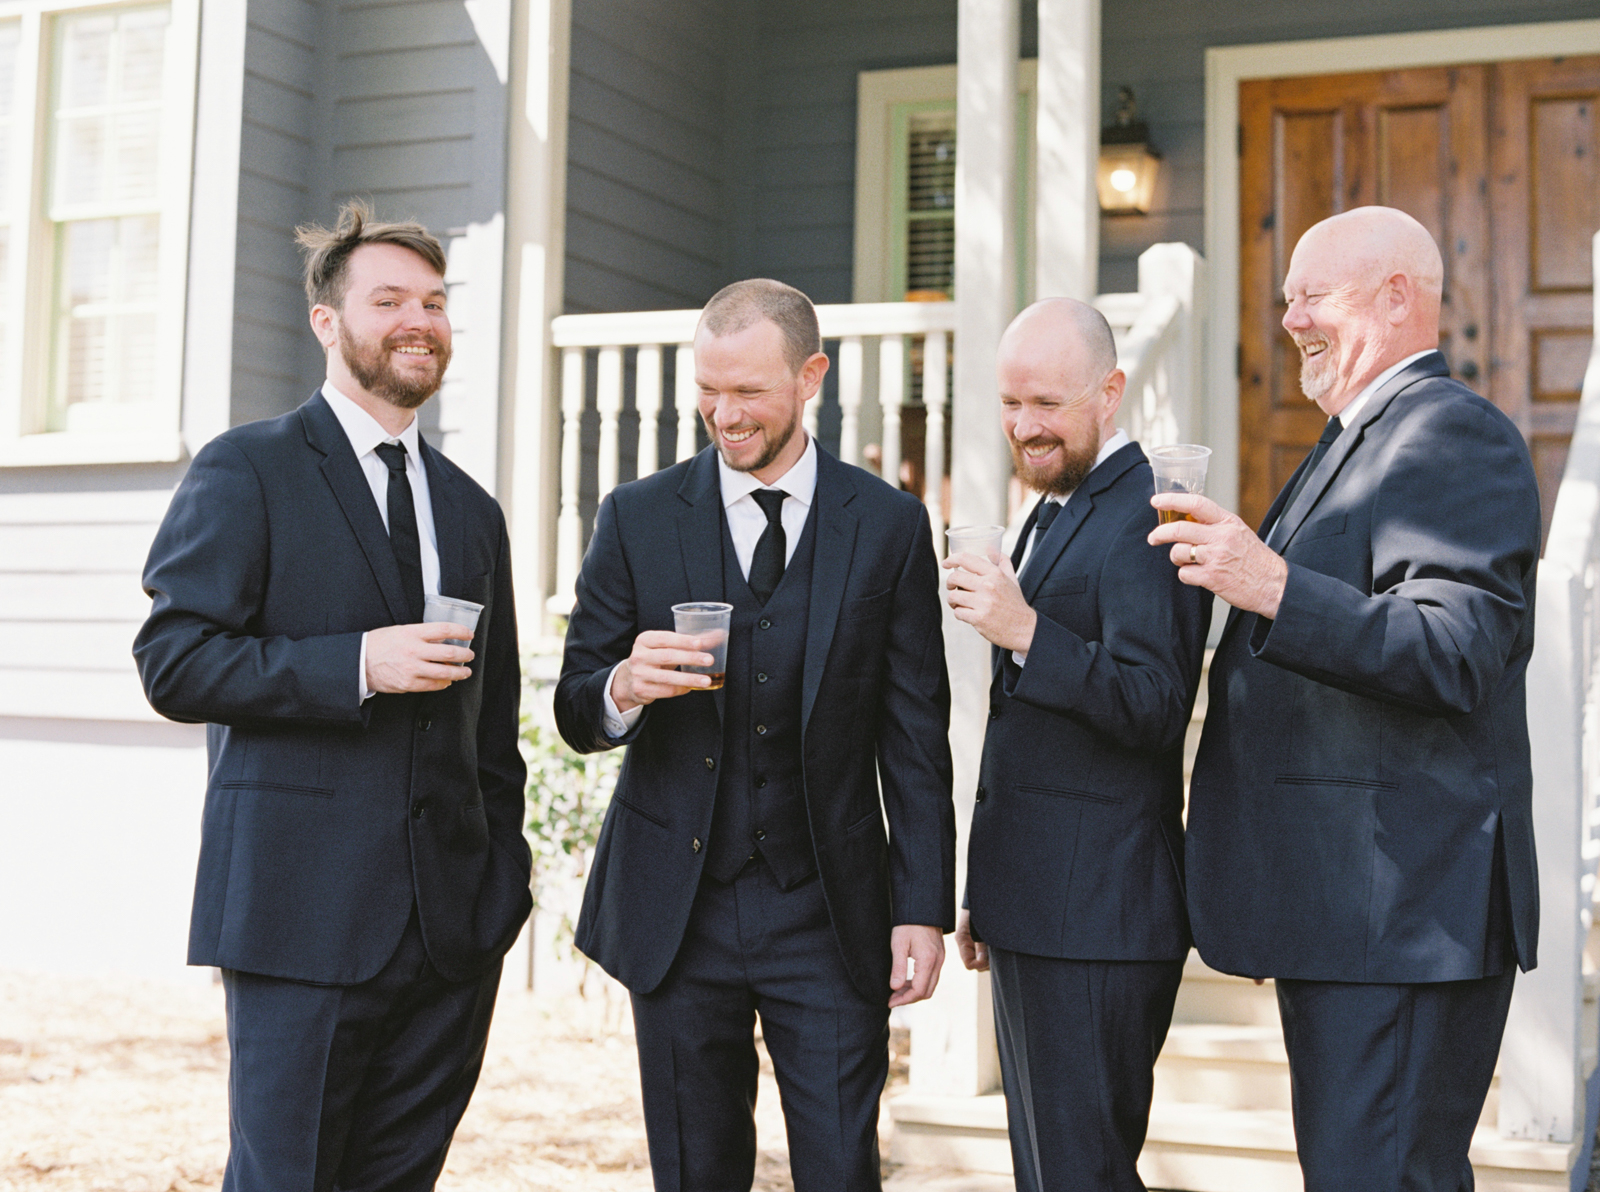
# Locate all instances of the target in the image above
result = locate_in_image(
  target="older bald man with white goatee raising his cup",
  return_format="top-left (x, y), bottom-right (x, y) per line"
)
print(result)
top-left (1150, 208), bottom-right (1539, 1192)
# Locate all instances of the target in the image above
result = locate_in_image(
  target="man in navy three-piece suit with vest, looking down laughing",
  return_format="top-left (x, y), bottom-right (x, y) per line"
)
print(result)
top-left (555, 278), bottom-right (955, 1192)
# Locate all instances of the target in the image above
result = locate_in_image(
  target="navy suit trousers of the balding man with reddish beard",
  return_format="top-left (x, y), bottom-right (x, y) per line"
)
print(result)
top-left (989, 946), bottom-right (1184, 1192)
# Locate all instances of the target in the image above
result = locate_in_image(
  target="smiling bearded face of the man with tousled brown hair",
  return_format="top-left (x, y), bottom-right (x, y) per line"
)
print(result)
top-left (321, 243), bottom-right (450, 410)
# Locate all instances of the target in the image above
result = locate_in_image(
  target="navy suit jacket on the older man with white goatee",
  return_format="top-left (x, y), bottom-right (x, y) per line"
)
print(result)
top-left (1187, 352), bottom-right (1539, 984)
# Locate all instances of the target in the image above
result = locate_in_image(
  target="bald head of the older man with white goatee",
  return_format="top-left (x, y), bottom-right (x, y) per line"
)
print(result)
top-left (1283, 206), bottom-right (1445, 414)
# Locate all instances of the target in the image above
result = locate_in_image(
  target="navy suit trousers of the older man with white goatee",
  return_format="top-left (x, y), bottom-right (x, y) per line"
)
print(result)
top-left (1277, 965), bottom-right (1517, 1192)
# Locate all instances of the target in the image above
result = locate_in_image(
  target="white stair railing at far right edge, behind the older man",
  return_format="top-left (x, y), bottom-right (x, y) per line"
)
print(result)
top-left (1499, 227), bottom-right (1600, 1149)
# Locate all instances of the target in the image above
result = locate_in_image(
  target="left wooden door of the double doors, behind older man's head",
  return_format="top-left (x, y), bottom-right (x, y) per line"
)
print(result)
top-left (1238, 67), bottom-right (1490, 525)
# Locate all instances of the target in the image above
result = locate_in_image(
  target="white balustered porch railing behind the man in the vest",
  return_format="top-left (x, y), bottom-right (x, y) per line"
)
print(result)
top-left (550, 302), bottom-right (955, 614)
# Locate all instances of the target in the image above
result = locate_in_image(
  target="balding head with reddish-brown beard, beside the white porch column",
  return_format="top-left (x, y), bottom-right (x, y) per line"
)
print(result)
top-left (997, 298), bottom-right (1125, 494)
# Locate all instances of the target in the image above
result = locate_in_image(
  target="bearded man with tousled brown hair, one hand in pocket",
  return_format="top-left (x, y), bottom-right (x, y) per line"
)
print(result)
top-left (134, 205), bottom-right (531, 1192)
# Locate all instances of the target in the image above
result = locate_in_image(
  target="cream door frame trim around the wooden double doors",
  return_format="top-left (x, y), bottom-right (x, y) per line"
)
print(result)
top-left (1203, 21), bottom-right (1600, 509)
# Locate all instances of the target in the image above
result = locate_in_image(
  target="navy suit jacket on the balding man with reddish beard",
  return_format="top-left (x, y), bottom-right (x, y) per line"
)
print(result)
top-left (966, 443), bottom-right (1211, 960)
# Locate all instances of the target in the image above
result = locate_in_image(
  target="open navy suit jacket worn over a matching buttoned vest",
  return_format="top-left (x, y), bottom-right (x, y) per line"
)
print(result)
top-left (555, 448), bottom-right (955, 998)
